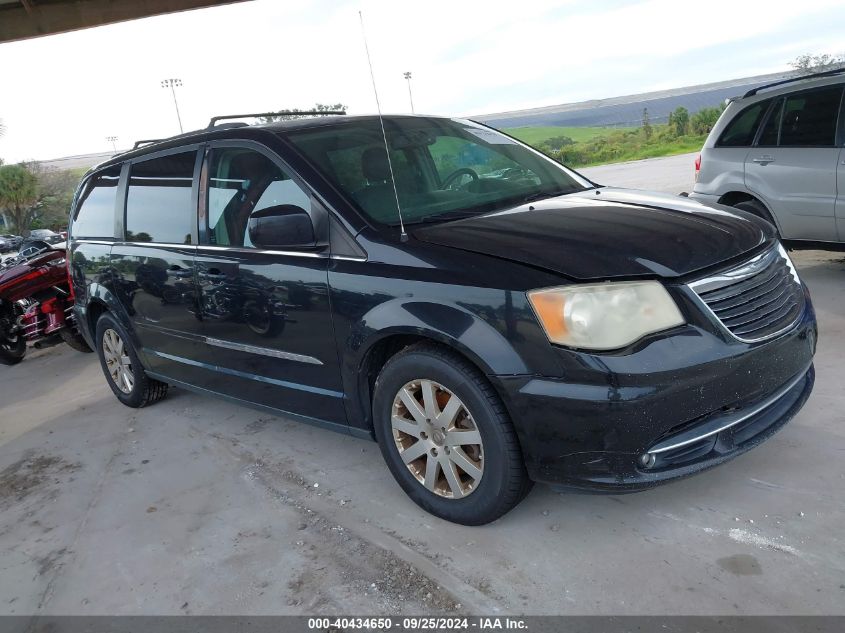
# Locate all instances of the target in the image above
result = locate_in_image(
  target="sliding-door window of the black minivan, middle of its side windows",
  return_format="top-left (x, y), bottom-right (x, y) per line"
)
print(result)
top-left (126, 151), bottom-right (197, 244)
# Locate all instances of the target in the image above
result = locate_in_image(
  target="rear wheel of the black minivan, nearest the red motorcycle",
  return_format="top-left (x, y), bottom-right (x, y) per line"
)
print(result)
top-left (96, 313), bottom-right (167, 409)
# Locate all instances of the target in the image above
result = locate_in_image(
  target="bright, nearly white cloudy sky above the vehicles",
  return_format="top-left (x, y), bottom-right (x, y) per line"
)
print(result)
top-left (0, 0), bottom-right (845, 163)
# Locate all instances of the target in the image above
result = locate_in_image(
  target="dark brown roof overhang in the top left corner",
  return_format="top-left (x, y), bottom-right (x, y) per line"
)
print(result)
top-left (0, 0), bottom-right (249, 43)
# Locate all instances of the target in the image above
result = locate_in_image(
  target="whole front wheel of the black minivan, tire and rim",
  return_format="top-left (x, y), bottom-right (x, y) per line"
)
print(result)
top-left (373, 344), bottom-right (532, 525)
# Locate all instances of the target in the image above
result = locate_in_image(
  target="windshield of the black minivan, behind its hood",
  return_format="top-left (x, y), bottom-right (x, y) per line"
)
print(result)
top-left (287, 117), bottom-right (592, 226)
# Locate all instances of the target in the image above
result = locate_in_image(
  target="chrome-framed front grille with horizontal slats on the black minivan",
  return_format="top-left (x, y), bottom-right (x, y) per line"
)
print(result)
top-left (690, 244), bottom-right (805, 343)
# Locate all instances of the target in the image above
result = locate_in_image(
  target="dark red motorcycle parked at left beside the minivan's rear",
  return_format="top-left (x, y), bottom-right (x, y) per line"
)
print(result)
top-left (0, 243), bottom-right (91, 365)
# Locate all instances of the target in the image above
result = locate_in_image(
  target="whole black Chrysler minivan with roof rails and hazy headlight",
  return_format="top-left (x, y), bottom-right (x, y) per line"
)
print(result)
top-left (69, 116), bottom-right (816, 525)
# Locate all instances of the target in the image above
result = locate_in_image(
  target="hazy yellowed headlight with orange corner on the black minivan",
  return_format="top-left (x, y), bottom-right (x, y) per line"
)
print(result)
top-left (528, 281), bottom-right (684, 350)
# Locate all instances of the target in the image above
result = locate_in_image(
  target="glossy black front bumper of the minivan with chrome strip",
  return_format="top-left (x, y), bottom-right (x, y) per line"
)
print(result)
top-left (494, 297), bottom-right (817, 492)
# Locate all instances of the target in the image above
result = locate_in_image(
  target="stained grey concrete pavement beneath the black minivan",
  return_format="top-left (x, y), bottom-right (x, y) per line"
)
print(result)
top-left (0, 252), bottom-right (845, 614)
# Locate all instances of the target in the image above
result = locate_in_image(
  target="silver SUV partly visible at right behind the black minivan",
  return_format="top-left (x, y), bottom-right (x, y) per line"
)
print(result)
top-left (690, 69), bottom-right (845, 248)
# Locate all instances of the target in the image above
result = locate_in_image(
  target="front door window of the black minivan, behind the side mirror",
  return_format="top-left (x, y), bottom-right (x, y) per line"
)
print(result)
top-left (208, 148), bottom-right (311, 247)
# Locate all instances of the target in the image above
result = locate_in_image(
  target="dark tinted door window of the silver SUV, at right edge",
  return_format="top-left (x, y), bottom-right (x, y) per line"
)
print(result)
top-left (780, 86), bottom-right (842, 147)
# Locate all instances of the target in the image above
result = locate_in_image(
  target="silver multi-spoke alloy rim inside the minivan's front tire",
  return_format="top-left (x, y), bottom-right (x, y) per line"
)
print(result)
top-left (391, 379), bottom-right (484, 499)
